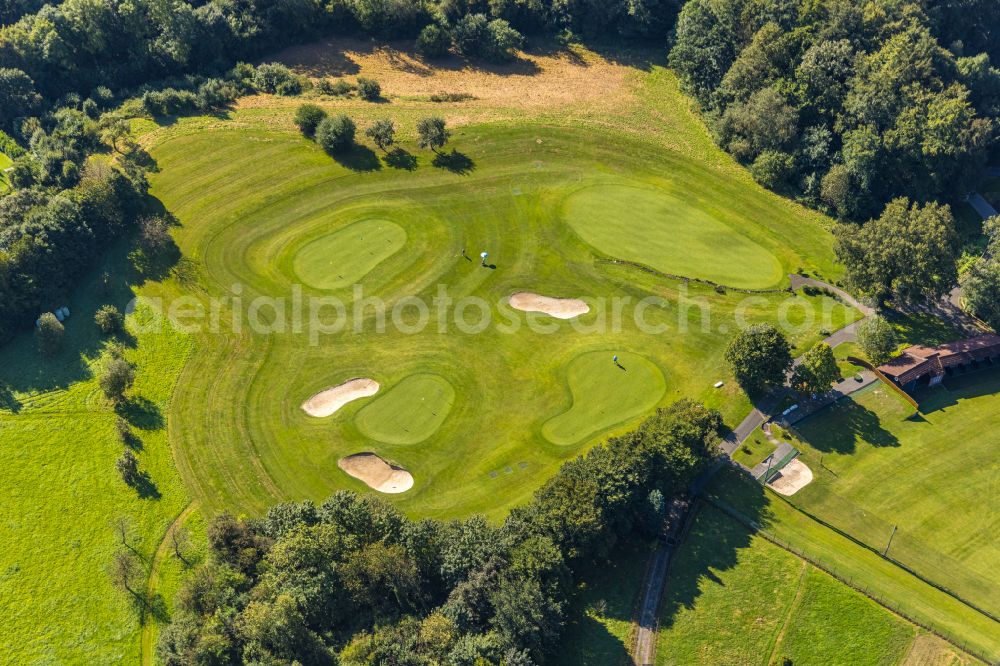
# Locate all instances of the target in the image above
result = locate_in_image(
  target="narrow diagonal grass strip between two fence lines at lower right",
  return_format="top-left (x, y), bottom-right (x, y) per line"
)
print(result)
top-left (708, 470), bottom-right (1000, 659)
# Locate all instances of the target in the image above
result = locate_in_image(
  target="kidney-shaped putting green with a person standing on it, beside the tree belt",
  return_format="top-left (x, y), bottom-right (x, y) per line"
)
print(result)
top-left (542, 351), bottom-right (667, 445)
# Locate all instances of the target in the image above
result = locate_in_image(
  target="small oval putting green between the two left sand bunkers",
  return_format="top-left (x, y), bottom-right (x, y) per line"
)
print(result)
top-left (354, 374), bottom-right (455, 444)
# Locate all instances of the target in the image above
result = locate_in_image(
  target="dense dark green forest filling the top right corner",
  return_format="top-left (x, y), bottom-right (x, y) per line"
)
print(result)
top-left (670, 0), bottom-right (1000, 220)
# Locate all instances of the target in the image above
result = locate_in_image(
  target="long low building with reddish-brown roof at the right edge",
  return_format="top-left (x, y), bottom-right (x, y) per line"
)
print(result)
top-left (879, 334), bottom-right (1000, 391)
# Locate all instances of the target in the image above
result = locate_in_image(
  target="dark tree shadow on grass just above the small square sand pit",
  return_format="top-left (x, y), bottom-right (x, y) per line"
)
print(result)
top-left (795, 396), bottom-right (900, 454)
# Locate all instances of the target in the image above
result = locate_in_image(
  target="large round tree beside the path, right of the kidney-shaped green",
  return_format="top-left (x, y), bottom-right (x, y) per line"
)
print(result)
top-left (726, 324), bottom-right (792, 395)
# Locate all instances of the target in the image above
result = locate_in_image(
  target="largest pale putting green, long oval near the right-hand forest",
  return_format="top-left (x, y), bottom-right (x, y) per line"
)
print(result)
top-left (563, 185), bottom-right (782, 289)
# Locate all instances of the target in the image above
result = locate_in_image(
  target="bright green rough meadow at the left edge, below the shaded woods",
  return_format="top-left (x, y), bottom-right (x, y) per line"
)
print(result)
top-left (0, 253), bottom-right (196, 663)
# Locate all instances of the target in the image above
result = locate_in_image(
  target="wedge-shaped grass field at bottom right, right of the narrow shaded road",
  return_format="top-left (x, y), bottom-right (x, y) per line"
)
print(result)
top-left (657, 506), bottom-right (916, 666)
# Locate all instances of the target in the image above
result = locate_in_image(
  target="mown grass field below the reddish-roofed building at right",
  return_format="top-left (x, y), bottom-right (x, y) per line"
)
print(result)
top-left (793, 371), bottom-right (1000, 614)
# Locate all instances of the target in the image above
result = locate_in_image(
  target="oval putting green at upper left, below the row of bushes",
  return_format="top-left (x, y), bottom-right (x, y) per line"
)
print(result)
top-left (293, 219), bottom-right (406, 289)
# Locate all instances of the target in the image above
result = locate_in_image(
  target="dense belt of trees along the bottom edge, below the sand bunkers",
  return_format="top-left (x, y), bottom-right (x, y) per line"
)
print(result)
top-left (158, 401), bottom-right (722, 666)
